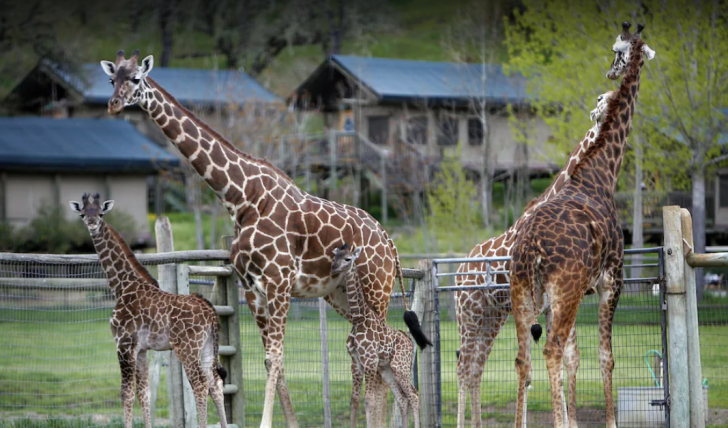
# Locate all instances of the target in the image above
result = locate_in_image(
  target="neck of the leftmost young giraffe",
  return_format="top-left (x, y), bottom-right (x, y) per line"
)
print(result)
top-left (92, 221), bottom-right (159, 300)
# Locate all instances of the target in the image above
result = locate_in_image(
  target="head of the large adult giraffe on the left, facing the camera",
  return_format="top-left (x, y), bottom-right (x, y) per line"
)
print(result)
top-left (101, 49), bottom-right (154, 114)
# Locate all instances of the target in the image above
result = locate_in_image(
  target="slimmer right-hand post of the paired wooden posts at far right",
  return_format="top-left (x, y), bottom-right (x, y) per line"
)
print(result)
top-left (680, 208), bottom-right (705, 428)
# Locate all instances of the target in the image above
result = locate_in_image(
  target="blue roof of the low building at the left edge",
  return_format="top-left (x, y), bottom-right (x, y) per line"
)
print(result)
top-left (0, 117), bottom-right (180, 172)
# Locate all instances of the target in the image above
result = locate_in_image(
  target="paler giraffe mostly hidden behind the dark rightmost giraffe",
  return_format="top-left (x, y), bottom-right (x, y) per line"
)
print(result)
top-left (455, 91), bottom-right (612, 428)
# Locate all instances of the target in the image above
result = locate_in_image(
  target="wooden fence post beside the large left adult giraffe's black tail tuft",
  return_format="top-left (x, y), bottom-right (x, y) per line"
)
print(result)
top-left (412, 260), bottom-right (439, 427)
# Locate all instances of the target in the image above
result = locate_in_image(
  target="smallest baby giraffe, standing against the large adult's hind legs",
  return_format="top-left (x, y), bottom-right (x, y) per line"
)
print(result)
top-left (331, 243), bottom-right (420, 428)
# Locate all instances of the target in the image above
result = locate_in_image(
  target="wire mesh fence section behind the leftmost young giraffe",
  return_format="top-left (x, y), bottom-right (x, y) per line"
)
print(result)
top-left (0, 260), bottom-right (226, 426)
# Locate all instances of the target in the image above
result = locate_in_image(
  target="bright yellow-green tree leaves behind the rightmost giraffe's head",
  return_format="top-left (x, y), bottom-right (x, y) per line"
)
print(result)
top-left (505, 0), bottom-right (728, 186)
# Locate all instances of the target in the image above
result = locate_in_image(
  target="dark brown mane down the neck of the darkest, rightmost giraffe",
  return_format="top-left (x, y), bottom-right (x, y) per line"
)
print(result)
top-left (572, 38), bottom-right (645, 176)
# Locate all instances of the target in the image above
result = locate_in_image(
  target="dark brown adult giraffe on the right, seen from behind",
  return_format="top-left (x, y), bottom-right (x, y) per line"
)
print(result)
top-left (511, 22), bottom-right (655, 428)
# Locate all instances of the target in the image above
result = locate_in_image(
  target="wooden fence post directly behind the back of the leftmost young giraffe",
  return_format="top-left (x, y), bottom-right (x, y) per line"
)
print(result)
top-left (150, 217), bottom-right (185, 428)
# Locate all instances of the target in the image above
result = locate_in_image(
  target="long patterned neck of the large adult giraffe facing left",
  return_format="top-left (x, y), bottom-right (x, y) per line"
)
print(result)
top-left (139, 77), bottom-right (293, 221)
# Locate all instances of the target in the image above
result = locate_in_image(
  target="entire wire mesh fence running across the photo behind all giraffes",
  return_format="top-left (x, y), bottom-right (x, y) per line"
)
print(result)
top-left (5, 246), bottom-right (728, 427)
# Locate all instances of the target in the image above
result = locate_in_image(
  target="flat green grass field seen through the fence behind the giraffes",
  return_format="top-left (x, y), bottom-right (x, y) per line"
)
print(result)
top-left (0, 288), bottom-right (728, 428)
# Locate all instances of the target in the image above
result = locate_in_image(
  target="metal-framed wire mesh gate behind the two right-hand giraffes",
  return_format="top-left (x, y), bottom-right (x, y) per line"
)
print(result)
top-left (430, 250), bottom-right (666, 427)
